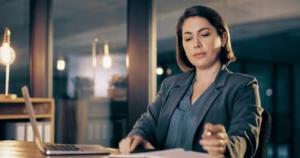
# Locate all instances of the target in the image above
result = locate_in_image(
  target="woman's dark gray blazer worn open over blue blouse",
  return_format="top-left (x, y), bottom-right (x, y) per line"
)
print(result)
top-left (129, 67), bottom-right (263, 157)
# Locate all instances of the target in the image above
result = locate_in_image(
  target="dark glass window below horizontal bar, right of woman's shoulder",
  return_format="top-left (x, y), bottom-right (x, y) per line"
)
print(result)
top-left (246, 62), bottom-right (295, 157)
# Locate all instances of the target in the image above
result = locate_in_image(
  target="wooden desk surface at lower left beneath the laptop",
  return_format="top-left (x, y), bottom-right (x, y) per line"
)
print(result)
top-left (0, 141), bottom-right (107, 158)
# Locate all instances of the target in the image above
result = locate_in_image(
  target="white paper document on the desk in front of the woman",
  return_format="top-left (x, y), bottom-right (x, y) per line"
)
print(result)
top-left (108, 148), bottom-right (208, 158)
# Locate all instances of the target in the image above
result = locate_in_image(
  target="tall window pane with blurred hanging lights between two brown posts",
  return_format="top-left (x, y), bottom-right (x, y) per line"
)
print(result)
top-left (53, 0), bottom-right (127, 146)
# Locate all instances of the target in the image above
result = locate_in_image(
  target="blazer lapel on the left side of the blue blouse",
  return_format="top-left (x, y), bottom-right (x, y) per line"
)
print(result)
top-left (156, 73), bottom-right (195, 148)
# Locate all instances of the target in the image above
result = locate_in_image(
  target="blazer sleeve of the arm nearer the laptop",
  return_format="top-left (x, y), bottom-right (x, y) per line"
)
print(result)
top-left (128, 80), bottom-right (171, 145)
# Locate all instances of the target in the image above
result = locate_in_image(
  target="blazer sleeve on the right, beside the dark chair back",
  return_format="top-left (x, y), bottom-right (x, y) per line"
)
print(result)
top-left (226, 79), bottom-right (263, 158)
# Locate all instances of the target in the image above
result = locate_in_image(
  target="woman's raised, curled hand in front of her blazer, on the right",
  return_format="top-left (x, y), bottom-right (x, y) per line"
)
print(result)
top-left (199, 123), bottom-right (228, 157)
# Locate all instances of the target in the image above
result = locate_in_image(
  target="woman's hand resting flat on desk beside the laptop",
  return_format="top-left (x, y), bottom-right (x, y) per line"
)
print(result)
top-left (119, 135), bottom-right (154, 154)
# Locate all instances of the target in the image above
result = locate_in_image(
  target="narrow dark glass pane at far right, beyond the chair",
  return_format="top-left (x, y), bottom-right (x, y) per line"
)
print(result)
top-left (273, 65), bottom-right (294, 157)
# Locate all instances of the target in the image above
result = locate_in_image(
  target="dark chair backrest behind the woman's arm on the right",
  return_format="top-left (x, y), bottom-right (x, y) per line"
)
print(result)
top-left (255, 110), bottom-right (271, 158)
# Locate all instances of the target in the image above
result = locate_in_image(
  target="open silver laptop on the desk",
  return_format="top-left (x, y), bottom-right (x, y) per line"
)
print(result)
top-left (22, 86), bottom-right (110, 155)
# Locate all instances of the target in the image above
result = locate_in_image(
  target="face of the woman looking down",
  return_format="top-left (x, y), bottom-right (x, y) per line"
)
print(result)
top-left (182, 16), bottom-right (224, 69)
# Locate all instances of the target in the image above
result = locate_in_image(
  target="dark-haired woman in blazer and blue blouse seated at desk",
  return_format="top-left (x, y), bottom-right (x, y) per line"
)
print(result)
top-left (119, 6), bottom-right (263, 157)
